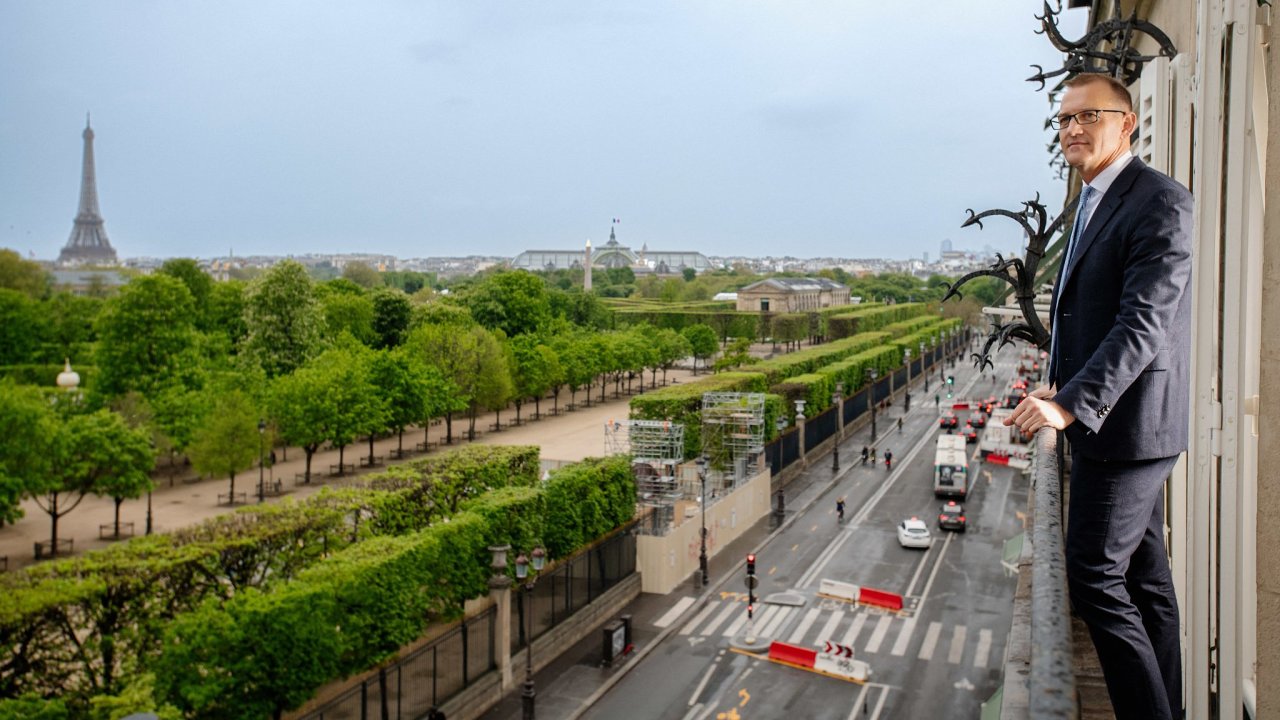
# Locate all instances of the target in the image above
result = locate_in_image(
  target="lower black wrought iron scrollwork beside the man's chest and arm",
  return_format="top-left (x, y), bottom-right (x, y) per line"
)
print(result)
top-left (942, 193), bottom-right (1079, 368)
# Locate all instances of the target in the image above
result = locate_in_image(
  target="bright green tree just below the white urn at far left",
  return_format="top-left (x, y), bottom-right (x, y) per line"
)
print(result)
top-left (28, 410), bottom-right (155, 553)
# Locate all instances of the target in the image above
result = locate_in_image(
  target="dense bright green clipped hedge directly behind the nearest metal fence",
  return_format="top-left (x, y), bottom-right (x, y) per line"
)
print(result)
top-left (155, 456), bottom-right (635, 719)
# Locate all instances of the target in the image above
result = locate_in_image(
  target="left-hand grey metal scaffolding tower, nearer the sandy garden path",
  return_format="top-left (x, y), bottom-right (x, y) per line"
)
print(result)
top-left (604, 420), bottom-right (696, 536)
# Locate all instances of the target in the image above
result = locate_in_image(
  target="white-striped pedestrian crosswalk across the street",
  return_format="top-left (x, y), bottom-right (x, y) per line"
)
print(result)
top-left (660, 600), bottom-right (1000, 667)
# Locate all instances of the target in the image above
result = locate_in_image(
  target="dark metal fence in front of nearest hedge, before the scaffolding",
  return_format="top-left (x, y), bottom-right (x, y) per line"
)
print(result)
top-left (300, 527), bottom-right (636, 720)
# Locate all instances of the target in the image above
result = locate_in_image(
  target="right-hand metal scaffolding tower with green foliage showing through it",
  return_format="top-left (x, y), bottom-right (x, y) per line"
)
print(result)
top-left (703, 392), bottom-right (764, 489)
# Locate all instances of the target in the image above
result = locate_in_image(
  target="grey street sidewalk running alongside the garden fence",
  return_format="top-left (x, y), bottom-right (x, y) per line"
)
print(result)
top-left (481, 368), bottom-right (959, 720)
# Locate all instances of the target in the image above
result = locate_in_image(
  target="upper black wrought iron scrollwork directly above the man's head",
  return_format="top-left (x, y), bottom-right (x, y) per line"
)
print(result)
top-left (1027, 3), bottom-right (1178, 90)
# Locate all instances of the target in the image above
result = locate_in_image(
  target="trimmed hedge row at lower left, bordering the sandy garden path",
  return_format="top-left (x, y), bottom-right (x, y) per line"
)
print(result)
top-left (0, 446), bottom-right (539, 703)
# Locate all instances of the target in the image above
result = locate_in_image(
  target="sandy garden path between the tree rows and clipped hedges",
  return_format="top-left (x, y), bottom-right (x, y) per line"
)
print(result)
top-left (0, 370), bottom-right (701, 570)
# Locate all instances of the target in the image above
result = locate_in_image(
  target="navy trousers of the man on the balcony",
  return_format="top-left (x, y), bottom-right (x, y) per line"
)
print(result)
top-left (1066, 455), bottom-right (1183, 720)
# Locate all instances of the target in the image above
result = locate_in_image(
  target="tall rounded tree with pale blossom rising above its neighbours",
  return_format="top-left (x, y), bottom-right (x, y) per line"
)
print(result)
top-left (244, 260), bottom-right (324, 378)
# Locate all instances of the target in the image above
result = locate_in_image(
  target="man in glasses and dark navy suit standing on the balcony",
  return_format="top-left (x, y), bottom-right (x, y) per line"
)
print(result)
top-left (1006, 74), bottom-right (1192, 720)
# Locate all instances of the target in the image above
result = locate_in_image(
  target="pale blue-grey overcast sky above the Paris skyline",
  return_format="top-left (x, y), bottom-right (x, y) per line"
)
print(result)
top-left (0, 0), bottom-right (1087, 259)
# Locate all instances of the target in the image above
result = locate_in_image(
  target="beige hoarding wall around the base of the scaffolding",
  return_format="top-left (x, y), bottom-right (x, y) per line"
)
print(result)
top-left (636, 468), bottom-right (769, 594)
